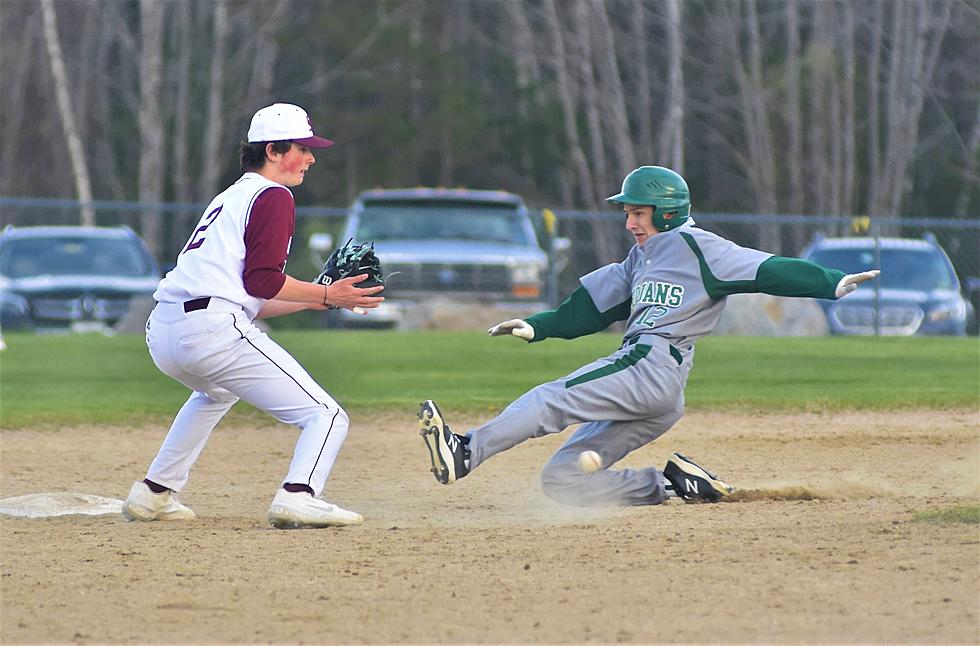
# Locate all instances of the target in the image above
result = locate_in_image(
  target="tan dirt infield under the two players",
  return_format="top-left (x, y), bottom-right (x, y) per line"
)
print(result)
top-left (0, 411), bottom-right (980, 644)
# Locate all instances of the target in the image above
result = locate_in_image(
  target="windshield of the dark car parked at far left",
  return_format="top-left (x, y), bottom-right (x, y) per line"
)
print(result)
top-left (0, 236), bottom-right (151, 278)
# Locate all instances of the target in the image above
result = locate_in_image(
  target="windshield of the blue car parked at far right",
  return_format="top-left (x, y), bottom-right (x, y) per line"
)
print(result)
top-left (810, 248), bottom-right (958, 291)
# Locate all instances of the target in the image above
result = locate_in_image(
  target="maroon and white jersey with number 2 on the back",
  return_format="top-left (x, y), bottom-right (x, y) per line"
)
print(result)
top-left (153, 172), bottom-right (296, 319)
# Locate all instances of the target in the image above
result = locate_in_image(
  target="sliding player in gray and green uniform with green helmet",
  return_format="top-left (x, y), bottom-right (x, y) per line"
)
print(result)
top-left (419, 166), bottom-right (879, 505)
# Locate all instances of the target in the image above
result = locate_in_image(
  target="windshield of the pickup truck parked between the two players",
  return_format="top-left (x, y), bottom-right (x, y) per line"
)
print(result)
top-left (355, 201), bottom-right (529, 245)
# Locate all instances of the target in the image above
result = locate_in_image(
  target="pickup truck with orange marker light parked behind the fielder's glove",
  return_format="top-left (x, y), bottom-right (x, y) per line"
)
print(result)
top-left (311, 188), bottom-right (568, 326)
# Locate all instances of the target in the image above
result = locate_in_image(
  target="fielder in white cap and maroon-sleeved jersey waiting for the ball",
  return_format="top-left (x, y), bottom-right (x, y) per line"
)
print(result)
top-left (123, 103), bottom-right (384, 528)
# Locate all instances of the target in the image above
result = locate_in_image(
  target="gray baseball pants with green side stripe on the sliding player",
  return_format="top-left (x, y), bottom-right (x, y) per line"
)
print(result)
top-left (468, 335), bottom-right (693, 506)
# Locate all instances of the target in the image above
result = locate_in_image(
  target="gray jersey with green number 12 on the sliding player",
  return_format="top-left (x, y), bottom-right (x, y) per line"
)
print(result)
top-left (581, 221), bottom-right (772, 348)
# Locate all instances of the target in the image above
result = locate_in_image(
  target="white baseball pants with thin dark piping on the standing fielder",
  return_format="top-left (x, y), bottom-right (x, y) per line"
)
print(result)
top-left (146, 298), bottom-right (348, 496)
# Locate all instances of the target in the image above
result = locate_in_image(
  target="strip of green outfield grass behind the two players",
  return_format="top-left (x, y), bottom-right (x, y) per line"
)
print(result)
top-left (0, 330), bottom-right (980, 428)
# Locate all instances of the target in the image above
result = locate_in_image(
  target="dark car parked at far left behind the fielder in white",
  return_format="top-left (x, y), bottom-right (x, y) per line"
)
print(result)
top-left (0, 226), bottom-right (160, 331)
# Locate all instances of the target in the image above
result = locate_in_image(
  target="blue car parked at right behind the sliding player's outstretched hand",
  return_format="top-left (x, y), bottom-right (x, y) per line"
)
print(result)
top-left (801, 235), bottom-right (976, 336)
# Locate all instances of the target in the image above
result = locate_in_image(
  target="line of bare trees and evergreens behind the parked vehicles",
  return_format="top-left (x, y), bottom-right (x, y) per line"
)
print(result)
top-left (0, 0), bottom-right (980, 264)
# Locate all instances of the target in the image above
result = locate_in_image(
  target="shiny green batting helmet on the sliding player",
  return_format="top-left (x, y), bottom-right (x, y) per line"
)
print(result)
top-left (606, 166), bottom-right (691, 231)
